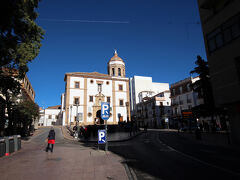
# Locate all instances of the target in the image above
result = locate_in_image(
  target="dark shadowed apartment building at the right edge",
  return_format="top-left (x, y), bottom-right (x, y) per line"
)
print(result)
top-left (198, 0), bottom-right (240, 145)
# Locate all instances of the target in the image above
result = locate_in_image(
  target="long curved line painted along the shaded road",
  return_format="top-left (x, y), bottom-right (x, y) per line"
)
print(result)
top-left (158, 138), bottom-right (240, 176)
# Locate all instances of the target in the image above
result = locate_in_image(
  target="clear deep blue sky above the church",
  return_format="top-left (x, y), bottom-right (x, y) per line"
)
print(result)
top-left (28, 0), bottom-right (206, 108)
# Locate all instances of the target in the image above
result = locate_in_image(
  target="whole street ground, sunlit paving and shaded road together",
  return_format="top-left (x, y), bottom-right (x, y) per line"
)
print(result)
top-left (0, 128), bottom-right (240, 180)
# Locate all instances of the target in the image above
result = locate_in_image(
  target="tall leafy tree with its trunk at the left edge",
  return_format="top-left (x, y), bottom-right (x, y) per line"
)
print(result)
top-left (0, 0), bottom-right (44, 135)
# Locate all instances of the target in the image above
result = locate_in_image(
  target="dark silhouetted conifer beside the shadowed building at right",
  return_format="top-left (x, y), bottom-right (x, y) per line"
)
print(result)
top-left (190, 56), bottom-right (215, 128)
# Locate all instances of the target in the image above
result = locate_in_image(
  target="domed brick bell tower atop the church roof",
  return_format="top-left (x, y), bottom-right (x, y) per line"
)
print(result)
top-left (108, 50), bottom-right (125, 77)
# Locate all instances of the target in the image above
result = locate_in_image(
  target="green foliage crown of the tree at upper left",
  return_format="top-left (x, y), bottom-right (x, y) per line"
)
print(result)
top-left (0, 0), bottom-right (44, 77)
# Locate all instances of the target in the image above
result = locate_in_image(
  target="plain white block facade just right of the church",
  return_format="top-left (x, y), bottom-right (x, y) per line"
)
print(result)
top-left (130, 76), bottom-right (169, 114)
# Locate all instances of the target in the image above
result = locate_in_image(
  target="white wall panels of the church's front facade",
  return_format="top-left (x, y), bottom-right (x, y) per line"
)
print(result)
top-left (63, 76), bottom-right (128, 124)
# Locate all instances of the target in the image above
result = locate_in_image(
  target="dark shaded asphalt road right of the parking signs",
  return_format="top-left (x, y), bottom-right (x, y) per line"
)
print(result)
top-left (109, 132), bottom-right (240, 180)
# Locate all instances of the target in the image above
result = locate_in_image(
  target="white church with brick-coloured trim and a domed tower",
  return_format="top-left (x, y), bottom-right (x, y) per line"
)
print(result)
top-left (61, 51), bottom-right (131, 125)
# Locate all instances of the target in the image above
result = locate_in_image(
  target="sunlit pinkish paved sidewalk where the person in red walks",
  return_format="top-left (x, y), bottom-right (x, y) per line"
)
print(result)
top-left (0, 127), bottom-right (128, 180)
